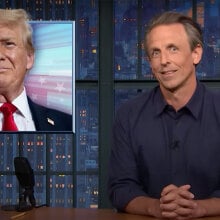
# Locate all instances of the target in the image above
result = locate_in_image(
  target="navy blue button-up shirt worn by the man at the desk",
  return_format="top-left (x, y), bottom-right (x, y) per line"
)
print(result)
top-left (108, 82), bottom-right (220, 210)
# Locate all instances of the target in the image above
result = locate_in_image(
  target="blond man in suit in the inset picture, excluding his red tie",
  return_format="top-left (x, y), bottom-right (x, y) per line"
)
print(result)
top-left (0, 9), bottom-right (72, 131)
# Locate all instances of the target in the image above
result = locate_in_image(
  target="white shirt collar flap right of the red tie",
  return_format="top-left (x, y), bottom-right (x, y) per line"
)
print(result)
top-left (12, 88), bottom-right (32, 120)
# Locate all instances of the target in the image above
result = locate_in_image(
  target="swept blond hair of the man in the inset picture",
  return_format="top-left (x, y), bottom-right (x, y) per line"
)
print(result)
top-left (0, 9), bottom-right (34, 53)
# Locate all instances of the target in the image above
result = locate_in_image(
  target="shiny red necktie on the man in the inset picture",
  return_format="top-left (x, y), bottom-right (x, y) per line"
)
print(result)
top-left (0, 102), bottom-right (18, 131)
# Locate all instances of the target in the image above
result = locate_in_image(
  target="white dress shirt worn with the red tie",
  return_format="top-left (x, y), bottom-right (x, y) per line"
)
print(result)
top-left (0, 88), bottom-right (36, 131)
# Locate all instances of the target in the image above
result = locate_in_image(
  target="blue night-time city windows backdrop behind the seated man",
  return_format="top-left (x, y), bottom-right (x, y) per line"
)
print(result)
top-left (0, 0), bottom-right (220, 208)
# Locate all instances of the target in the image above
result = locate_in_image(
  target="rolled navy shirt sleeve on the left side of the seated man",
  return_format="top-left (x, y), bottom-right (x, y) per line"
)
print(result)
top-left (108, 107), bottom-right (146, 211)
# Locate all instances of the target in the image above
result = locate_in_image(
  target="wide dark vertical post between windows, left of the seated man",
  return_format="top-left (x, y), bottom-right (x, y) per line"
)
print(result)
top-left (99, 0), bottom-right (113, 208)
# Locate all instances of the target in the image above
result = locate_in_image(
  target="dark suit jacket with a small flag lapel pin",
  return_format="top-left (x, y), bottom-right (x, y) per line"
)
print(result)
top-left (28, 98), bottom-right (73, 131)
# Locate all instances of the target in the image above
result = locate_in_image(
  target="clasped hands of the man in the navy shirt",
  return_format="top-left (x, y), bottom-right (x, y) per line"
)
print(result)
top-left (160, 184), bottom-right (205, 219)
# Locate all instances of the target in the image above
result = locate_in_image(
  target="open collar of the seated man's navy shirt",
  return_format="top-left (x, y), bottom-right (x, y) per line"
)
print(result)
top-left (154, 81), bottom-right (205, 119)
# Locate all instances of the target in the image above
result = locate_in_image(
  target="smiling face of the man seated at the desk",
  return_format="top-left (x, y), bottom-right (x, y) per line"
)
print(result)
top-left (147, 24), bottom-right (202, 91)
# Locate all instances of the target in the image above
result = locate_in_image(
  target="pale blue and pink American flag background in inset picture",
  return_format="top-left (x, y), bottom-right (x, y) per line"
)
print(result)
top-left (25, 21), bottom-right (75, 114)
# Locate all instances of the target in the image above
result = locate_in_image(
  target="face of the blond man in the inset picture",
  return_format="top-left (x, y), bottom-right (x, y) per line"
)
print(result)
top-left (0, 24), bottom-right (34, 98)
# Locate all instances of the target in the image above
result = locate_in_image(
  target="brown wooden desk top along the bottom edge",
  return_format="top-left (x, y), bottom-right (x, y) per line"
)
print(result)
top-left (0, 207), bottom-right (220, 220)
